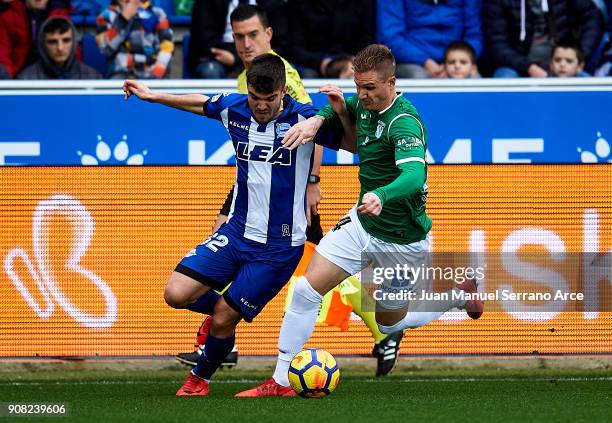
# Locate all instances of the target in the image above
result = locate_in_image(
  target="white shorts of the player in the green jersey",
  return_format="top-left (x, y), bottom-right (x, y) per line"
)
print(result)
top-left (316, 208), bottom-right (430, 310)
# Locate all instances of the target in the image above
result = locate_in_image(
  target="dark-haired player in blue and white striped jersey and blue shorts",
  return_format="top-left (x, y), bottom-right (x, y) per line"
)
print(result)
top-left (123, 54), bottom-right (339, 396)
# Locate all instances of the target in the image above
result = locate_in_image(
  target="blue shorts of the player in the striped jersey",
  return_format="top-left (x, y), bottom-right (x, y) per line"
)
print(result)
top-left (175, 224), bottom-right (304, 322)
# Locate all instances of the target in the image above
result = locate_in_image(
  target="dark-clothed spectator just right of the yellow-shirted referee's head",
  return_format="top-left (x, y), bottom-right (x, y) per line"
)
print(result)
top-left (287, 0), bottom-right (376, 78)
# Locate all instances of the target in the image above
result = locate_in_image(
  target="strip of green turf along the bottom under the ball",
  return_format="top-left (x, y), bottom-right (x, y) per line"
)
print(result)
top-left (0, 369), bottom-right (612, 423)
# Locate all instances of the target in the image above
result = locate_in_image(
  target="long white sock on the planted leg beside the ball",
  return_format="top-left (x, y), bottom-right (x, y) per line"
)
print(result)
top-left (272, 276), bottom-right (323, 386)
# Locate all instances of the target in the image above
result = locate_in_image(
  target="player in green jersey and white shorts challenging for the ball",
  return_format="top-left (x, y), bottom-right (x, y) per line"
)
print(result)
top-left (236, 44), bottom-right (484, 397)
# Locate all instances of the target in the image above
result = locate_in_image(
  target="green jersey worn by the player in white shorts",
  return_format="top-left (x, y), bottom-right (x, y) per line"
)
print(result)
top-left (318, 94), bottom-right (431, 244)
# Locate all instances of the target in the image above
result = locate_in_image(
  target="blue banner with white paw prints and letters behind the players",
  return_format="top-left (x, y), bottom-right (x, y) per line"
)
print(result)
top-left (0, 91), bottom-right (612, 165)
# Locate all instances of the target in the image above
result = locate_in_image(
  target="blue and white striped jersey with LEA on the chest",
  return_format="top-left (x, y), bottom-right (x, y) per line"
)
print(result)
top-left (204, 94), bottom-right (338, 246)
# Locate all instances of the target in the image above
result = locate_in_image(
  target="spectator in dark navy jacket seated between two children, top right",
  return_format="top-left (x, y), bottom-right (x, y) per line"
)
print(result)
top-left (483, 0), bottom-right (603, 78)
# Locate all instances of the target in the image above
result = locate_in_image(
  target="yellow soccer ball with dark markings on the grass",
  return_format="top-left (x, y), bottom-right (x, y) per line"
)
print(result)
top-left (289, 348), bottom-right (340, 398)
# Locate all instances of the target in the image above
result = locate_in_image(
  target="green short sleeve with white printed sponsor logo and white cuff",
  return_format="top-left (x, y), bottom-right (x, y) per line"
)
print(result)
top-left (388, 113), bottom-right (427, 167)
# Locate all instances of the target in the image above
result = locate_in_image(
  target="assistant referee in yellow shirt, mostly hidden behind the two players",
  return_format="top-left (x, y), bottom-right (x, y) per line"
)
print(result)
top-left (176, 4), bottom-right (403, 376)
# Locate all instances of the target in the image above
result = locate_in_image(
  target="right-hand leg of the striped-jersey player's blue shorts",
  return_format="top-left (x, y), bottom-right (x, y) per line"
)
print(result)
top-left (223, 246), bottom-right (304, 322)
